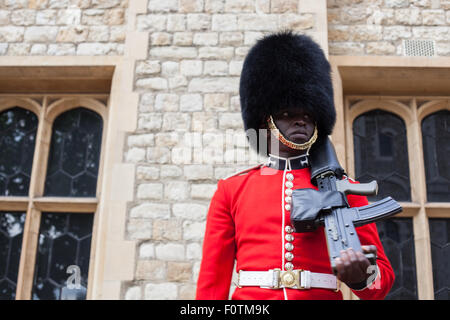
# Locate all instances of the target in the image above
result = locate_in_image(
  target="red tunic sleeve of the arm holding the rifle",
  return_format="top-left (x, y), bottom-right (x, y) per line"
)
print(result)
top-left (347, 195), bottom-right (395, 300)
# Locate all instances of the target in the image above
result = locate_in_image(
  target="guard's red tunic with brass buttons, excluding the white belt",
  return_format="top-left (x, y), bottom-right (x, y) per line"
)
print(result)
top-left (196, 167), bottom-right (394, 300)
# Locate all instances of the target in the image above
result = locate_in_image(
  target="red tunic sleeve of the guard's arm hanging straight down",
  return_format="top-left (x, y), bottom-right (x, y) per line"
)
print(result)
top-left (196, 180), bottom-right (236, 300)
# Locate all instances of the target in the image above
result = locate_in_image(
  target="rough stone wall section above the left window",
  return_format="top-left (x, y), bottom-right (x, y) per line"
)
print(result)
top-left (0, 0), bottom-right (128, 56)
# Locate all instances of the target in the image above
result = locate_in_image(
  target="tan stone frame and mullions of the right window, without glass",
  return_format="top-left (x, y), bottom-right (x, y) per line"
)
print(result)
top-left (344, 95), bottom-right (450, 299)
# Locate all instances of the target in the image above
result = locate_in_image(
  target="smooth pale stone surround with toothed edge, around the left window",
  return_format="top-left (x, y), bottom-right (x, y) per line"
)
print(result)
top-left (0, 0), bottom-right (148, 300)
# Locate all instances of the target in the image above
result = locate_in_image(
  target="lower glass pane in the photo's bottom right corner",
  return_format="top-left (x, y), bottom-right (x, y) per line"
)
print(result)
top-left (429, 218), bottom-right (450, 300)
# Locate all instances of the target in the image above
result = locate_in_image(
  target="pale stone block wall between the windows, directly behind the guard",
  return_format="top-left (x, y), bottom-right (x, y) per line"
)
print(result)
top-left (122, 0), bottom-right (320, 299)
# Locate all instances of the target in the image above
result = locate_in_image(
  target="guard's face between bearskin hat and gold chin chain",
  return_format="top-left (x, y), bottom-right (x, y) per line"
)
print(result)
top-left (272, 110), bottom-right (315, 143)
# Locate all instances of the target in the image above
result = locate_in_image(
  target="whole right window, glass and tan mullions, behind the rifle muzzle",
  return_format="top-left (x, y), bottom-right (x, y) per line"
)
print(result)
top-left (346, 96), bottom-right (450, 300)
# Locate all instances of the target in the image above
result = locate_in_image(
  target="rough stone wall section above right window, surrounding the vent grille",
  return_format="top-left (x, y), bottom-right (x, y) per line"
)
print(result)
top-left (327, 0), bottom-right (450, 56)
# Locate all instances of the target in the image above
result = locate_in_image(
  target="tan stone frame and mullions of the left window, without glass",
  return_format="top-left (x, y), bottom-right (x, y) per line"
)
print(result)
top-left (0, 94), bottom-right (110, 300)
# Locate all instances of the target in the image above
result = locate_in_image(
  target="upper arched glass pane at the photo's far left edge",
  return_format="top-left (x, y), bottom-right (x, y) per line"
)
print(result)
top-left (0, 107), bottom-right (38, 196)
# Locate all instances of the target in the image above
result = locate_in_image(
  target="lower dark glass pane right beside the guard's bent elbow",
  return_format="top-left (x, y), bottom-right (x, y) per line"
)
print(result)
top-left (377, 218), bottom-right (418, 300)
